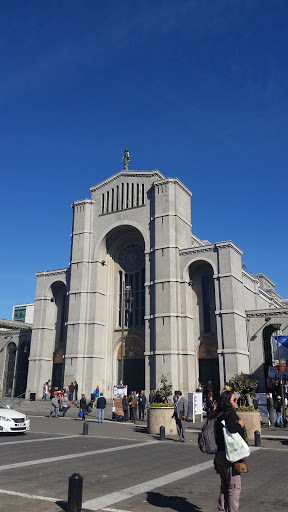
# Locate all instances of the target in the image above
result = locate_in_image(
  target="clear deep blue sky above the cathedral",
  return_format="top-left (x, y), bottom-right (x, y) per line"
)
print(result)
top-left (0, 0), bottom-right (288, 318)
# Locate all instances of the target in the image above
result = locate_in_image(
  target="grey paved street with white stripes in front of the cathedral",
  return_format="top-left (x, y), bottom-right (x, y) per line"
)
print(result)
top-left (0, 404), bottom-right (288, 512)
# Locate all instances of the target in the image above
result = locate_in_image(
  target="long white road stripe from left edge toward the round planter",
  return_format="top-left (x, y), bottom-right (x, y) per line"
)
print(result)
top-left (0, 437), bottom-right (159, 471)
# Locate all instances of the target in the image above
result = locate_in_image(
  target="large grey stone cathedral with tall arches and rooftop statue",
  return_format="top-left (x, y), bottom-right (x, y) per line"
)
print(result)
top-left (8, 162), bottom-right (288, 398)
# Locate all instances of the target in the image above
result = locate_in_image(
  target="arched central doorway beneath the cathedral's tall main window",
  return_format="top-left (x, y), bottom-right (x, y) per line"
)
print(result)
top-left (117, 335), bottom-right (145, 393)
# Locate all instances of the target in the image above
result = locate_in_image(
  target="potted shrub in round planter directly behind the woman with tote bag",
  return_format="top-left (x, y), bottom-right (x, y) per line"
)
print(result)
top-left (231, 372), bottom-right (261, 441)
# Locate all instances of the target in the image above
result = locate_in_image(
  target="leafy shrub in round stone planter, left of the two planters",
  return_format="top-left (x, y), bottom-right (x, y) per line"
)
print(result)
top-left (147, 375), bottom-right (177, 435)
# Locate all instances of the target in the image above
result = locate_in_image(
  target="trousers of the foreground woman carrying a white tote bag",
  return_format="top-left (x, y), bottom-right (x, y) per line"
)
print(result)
top-left (215, 450), bottom-right (241, 512)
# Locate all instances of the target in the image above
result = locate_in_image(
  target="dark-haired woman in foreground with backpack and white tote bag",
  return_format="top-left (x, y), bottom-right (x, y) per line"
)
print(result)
top-left (214, 391), bottom-right (245, 512)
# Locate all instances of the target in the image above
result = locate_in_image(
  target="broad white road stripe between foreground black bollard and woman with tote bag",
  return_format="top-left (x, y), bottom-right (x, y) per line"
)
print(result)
top-left (83, 460), bottom-right (214, 510)
